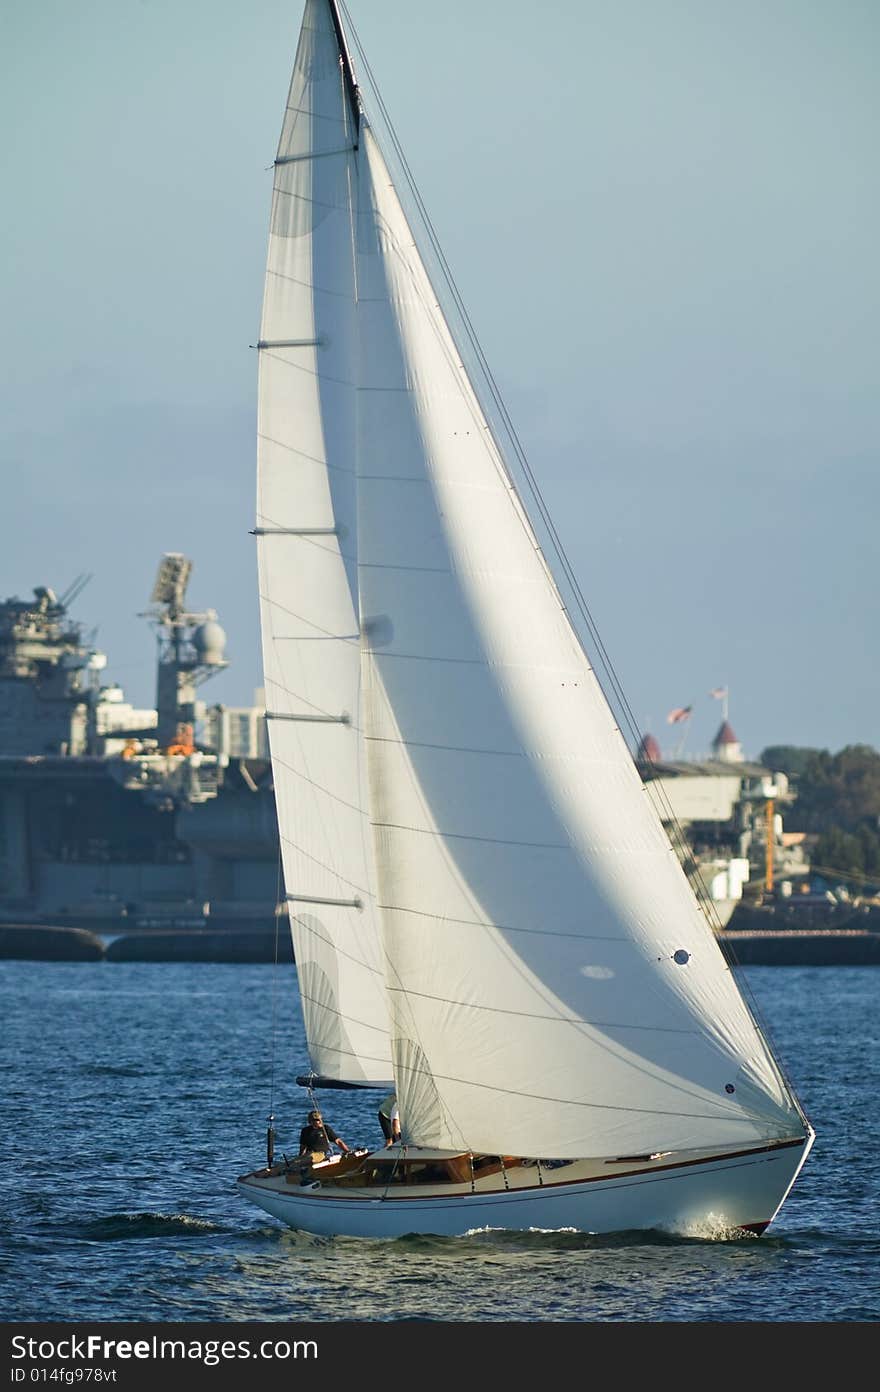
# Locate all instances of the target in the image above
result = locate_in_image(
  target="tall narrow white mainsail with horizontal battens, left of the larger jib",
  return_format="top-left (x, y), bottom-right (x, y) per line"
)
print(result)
top-left (256, 0), bottom-right (391, 1082)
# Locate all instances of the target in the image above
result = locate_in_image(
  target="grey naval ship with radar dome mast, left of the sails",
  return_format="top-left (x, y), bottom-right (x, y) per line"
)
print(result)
top-left (0, 553), bottom-right (283, 940)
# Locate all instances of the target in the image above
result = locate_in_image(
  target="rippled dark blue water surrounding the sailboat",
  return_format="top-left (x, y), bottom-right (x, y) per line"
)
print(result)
top-left (0, 962), bottom-right (880, 1322)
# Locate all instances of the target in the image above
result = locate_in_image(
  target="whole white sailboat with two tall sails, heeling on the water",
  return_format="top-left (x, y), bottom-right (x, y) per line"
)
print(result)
top-left (238, 0), bottom-right (813, 1237)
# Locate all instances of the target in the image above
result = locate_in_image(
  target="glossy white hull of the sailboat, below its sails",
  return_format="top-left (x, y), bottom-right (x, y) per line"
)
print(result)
top-left (238, 1130), bottom-right (813, 1237)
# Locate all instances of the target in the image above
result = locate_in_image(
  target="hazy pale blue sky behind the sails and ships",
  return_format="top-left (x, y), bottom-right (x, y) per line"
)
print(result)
top-left (0, 0), bottom-right (880, 754)
